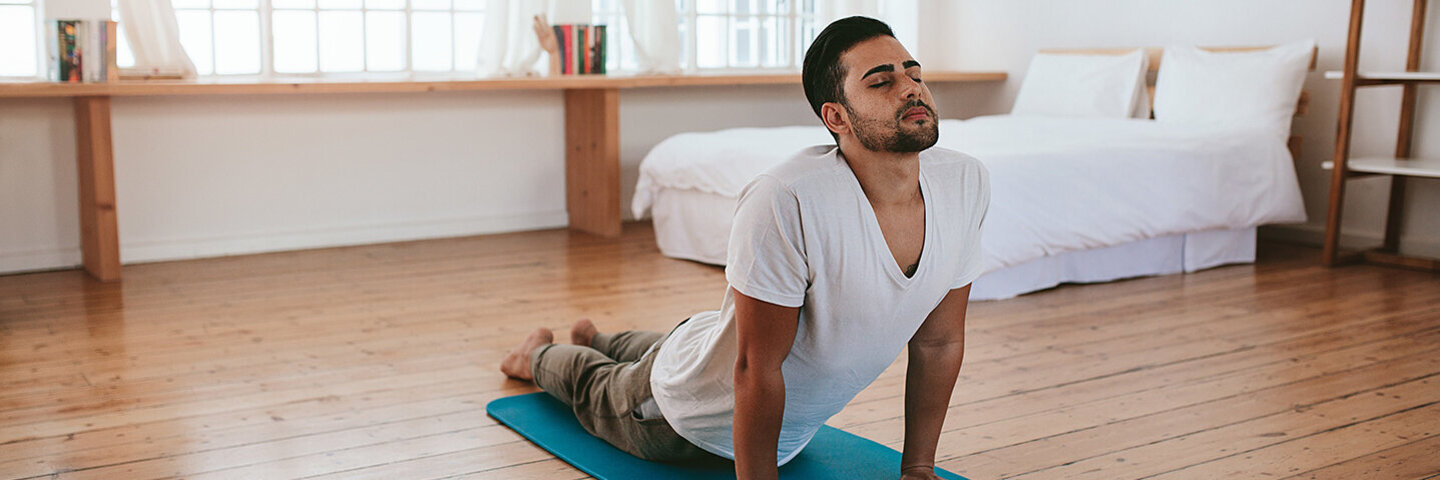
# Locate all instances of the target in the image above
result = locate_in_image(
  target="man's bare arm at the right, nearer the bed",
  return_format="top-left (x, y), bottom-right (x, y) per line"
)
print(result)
top-left (900, 285), bottom-right (971, 479)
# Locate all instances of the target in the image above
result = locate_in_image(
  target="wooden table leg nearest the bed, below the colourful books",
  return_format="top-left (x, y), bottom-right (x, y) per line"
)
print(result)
top-left (564, 88), bottom-right (621, 236)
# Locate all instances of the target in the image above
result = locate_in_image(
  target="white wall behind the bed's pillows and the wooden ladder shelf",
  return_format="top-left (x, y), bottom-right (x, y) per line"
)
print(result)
top-left (920, 0), bottom-right (1440, 257)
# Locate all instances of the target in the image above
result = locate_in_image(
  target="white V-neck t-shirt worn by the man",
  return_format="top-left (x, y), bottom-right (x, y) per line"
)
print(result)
top-left (649, 146), bottom-right (989, 464)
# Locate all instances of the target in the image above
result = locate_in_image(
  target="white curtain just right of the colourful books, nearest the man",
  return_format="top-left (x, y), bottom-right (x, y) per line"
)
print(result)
top-left (625, 0), bottom-right (683, 74)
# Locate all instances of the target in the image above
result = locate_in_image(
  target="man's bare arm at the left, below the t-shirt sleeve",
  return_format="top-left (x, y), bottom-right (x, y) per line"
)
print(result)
top-left (732, 288), bottom-right (801, 480)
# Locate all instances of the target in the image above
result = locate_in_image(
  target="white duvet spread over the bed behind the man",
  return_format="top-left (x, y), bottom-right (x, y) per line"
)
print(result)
top-left (632, 115), bottom-right (1305, 272)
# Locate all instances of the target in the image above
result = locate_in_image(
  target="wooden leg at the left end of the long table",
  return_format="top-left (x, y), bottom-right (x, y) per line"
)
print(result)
top-left (75, 97), bottom-right (120, 281)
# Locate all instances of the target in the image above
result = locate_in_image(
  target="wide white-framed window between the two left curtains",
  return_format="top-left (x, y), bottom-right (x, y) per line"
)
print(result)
top-left (173, 0), bottom-right (485, 76)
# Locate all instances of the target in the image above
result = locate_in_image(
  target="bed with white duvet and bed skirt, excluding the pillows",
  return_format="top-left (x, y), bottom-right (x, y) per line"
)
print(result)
top-left (632, 43), bottom-right (1306, 300)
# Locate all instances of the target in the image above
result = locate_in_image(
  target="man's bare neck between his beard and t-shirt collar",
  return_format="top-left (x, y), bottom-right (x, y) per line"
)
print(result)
top-left (841, 138), bottom-right (922, 206)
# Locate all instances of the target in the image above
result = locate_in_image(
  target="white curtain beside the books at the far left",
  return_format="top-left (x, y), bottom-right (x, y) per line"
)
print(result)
top-left (120, 0), bottom-right (196, 78)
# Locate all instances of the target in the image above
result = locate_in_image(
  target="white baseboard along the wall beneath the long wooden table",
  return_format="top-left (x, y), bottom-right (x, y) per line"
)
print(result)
top-left (0, 210), bottom-right (569, 274)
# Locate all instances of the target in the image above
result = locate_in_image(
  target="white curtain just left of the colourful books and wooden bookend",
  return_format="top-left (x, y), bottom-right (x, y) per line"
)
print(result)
top-left (475, 0), bottom-right (592, 76)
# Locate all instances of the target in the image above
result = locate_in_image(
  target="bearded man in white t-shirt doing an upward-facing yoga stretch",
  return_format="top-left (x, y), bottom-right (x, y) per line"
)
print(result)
top-left (501, 17), bottom-right (989, 479)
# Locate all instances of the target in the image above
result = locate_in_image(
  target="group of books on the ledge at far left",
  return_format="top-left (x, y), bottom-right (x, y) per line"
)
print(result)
top-left (46, 20), bottom-right (120, 84)
